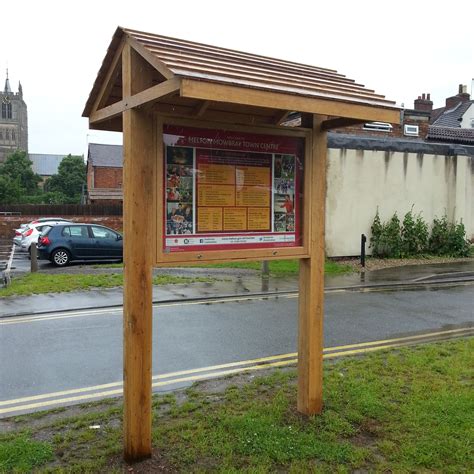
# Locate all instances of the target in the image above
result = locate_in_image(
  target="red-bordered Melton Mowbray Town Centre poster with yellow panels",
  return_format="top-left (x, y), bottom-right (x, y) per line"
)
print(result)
top-left (163, 125), bottom-right (304, 252)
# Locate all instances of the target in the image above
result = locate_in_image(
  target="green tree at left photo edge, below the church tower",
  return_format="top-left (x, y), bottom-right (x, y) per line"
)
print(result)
top-left (0, 150), bottom-right (41, 204)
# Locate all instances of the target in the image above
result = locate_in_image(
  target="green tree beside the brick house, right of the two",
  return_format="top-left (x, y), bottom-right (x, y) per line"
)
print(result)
top-left (44, 155), bottom-right (86, 203)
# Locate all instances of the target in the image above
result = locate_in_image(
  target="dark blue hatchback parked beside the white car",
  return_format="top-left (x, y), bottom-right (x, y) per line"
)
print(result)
top-left (37, 224), bottom-right (123, 267)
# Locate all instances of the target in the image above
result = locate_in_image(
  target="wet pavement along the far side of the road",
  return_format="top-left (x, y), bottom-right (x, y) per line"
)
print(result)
top-left (0, 261), bottom-right (474, 318)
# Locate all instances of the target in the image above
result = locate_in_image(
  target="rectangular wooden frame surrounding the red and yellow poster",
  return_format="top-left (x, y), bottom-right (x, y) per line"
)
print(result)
top-left (154, 114), bottom-right (312, 267)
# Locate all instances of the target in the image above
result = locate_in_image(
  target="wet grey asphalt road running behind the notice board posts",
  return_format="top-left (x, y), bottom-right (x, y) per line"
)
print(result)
top-left (0, 284), bottom-right (474, 415)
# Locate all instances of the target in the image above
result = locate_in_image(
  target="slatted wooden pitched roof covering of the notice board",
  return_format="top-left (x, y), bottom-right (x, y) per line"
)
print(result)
top-left (83, 27), bottom-right (398, 117)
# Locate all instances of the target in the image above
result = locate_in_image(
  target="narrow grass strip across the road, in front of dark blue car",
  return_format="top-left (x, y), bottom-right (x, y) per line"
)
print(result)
top-left (0, 273), bottom-right (215, 298)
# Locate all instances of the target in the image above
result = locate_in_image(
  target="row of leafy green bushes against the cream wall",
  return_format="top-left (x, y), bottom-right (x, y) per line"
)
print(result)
top-left (370, 208), bottom-right (470, 258)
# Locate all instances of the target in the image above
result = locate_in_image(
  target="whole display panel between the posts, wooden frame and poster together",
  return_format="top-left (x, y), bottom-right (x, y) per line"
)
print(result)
top-left (156, 117), bottom-right (311, 266)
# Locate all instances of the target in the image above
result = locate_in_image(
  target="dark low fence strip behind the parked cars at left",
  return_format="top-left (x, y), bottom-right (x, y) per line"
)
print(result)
top-left (0, 204), bottom-right (122, 217)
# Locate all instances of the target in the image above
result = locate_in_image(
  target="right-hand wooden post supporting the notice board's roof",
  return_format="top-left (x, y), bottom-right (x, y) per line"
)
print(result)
top-left (297, 115), bottom-right (327, 415)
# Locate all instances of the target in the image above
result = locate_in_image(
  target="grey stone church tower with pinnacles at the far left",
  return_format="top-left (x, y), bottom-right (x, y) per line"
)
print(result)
top-left (0, 69), bottom-right (28, 163)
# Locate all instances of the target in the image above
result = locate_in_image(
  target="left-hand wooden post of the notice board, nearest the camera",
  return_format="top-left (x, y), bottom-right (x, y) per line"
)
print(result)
top-left (122, 44), bottom-right (156, 461)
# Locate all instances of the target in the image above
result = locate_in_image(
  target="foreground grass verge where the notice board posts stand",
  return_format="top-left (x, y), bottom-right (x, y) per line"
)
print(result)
top-left (4, 339), bottom-right (474, 473)
